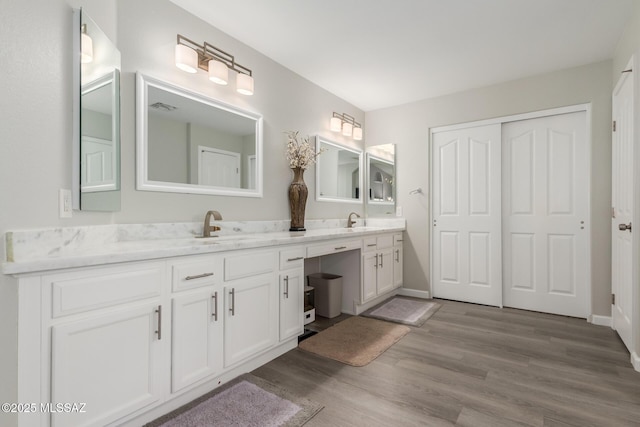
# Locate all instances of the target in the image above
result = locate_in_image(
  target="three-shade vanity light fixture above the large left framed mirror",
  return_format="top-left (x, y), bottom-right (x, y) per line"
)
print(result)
top-left (175, 34), bottom-right (253, 95)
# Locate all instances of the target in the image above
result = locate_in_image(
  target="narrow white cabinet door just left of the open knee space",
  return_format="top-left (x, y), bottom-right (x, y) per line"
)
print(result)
top-left (280, 268), bottom-right (304, 341)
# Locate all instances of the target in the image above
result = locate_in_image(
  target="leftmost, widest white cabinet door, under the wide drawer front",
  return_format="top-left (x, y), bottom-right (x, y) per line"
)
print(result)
top-left (51, 305), bottom-right (164, 427)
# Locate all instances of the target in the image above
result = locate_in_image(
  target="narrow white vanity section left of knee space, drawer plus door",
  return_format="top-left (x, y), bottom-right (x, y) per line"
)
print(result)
top-left (279, 247), bottom-right (305, 341)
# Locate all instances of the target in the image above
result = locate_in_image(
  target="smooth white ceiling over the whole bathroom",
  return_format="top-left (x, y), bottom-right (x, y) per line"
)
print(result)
top-left (171, 0), bottom-right (637, 111)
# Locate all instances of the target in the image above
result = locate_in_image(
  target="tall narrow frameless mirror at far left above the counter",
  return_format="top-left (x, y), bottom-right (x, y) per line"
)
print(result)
top-left (72, 10), bottom-right (120, 212)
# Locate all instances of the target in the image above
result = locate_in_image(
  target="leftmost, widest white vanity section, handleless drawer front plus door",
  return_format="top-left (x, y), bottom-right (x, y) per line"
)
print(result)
top-left (44, 263), bottom-right (167, 426)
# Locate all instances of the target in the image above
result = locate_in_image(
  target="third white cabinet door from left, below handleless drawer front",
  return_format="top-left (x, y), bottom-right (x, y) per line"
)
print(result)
top-left (224, 274), bottom-right (278, 367)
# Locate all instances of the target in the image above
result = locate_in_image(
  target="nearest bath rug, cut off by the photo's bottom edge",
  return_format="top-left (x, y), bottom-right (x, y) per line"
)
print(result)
top-left (145, 374), bottom-right (323, 427)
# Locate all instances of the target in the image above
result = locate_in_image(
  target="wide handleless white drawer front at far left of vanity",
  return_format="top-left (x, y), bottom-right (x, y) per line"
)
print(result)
top-left (44, 263), bottom-right (164, 318)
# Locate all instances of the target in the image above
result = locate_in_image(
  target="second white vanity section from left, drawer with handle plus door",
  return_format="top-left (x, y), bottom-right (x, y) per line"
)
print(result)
top-left (170, 255), bottom-right (224, 393)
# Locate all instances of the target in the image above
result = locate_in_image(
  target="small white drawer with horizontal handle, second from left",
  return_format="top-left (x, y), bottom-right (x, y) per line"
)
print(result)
top-left (171, 256), bottom-right (222, 292)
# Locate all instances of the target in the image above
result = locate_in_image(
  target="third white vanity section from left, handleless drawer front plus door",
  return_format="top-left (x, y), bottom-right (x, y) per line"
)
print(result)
top-left (224, 250), bottom-right (278, 368)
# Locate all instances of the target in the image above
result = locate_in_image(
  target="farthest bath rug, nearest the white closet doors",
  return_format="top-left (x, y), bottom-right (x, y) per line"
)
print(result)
top-left (362, 297), bottom-right (440, 327)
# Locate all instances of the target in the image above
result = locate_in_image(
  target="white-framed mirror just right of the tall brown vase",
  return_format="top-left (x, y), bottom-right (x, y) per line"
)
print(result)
top-left (316, 136), bottom-right (363, 203)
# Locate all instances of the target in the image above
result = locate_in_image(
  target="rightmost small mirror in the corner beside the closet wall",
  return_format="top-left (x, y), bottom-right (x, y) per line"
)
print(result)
top-left (366, 144), bottom-right (396, 216)
